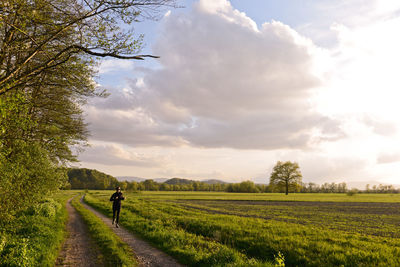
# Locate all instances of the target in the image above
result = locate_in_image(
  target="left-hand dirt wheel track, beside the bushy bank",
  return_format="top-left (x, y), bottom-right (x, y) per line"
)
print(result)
top-left (55, 196), bottom-right (104, 267)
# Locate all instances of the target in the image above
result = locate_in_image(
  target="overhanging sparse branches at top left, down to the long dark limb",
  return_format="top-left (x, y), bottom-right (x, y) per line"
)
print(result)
top-left (0, 0), bottom-right (174, 95)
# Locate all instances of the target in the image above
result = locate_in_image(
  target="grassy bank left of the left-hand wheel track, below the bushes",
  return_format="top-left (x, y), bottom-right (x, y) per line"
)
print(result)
top-left (0, 192), bottom-right (76, 267)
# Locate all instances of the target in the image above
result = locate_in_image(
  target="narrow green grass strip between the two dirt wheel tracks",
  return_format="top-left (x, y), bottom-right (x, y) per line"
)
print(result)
top-left (71, 197), bottom-right (138, 267)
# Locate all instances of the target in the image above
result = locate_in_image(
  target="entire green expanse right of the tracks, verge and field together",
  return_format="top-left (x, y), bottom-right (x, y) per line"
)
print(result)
top-left (86, 191), bottom-right (400, 266)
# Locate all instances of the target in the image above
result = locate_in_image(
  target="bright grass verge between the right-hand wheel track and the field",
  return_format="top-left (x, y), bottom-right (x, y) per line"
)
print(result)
top-left (84, 194), bottom-right (274, 266)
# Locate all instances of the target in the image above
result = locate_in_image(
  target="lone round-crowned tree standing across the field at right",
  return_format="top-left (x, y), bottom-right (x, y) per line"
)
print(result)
top-left (269, 161), bottom-right (302, 195)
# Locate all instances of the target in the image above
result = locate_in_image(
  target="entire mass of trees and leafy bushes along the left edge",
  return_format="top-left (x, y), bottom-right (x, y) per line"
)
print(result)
top-left (0, 0), bottom-right (174, 222)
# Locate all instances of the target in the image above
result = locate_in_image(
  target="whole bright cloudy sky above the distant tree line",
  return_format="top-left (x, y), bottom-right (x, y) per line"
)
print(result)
top-left (79, 0), bottom-right (400, 184)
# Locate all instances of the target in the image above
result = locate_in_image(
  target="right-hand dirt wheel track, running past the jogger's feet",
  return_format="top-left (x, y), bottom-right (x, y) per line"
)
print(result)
top-left (81, 199), bottom-right (183, 267)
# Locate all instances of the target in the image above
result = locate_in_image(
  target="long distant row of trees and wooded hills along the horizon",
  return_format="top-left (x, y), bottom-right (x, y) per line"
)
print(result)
top-left (64, 168), bottom-right (400, 193)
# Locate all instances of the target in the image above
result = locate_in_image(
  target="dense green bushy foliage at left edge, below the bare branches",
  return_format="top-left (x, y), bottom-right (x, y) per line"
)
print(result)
top-left (0, 93), bottom-right (66, 224)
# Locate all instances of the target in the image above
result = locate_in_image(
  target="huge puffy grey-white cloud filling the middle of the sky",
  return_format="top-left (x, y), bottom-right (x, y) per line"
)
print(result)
top-left (88, 0), bottom-right (343, 150)
